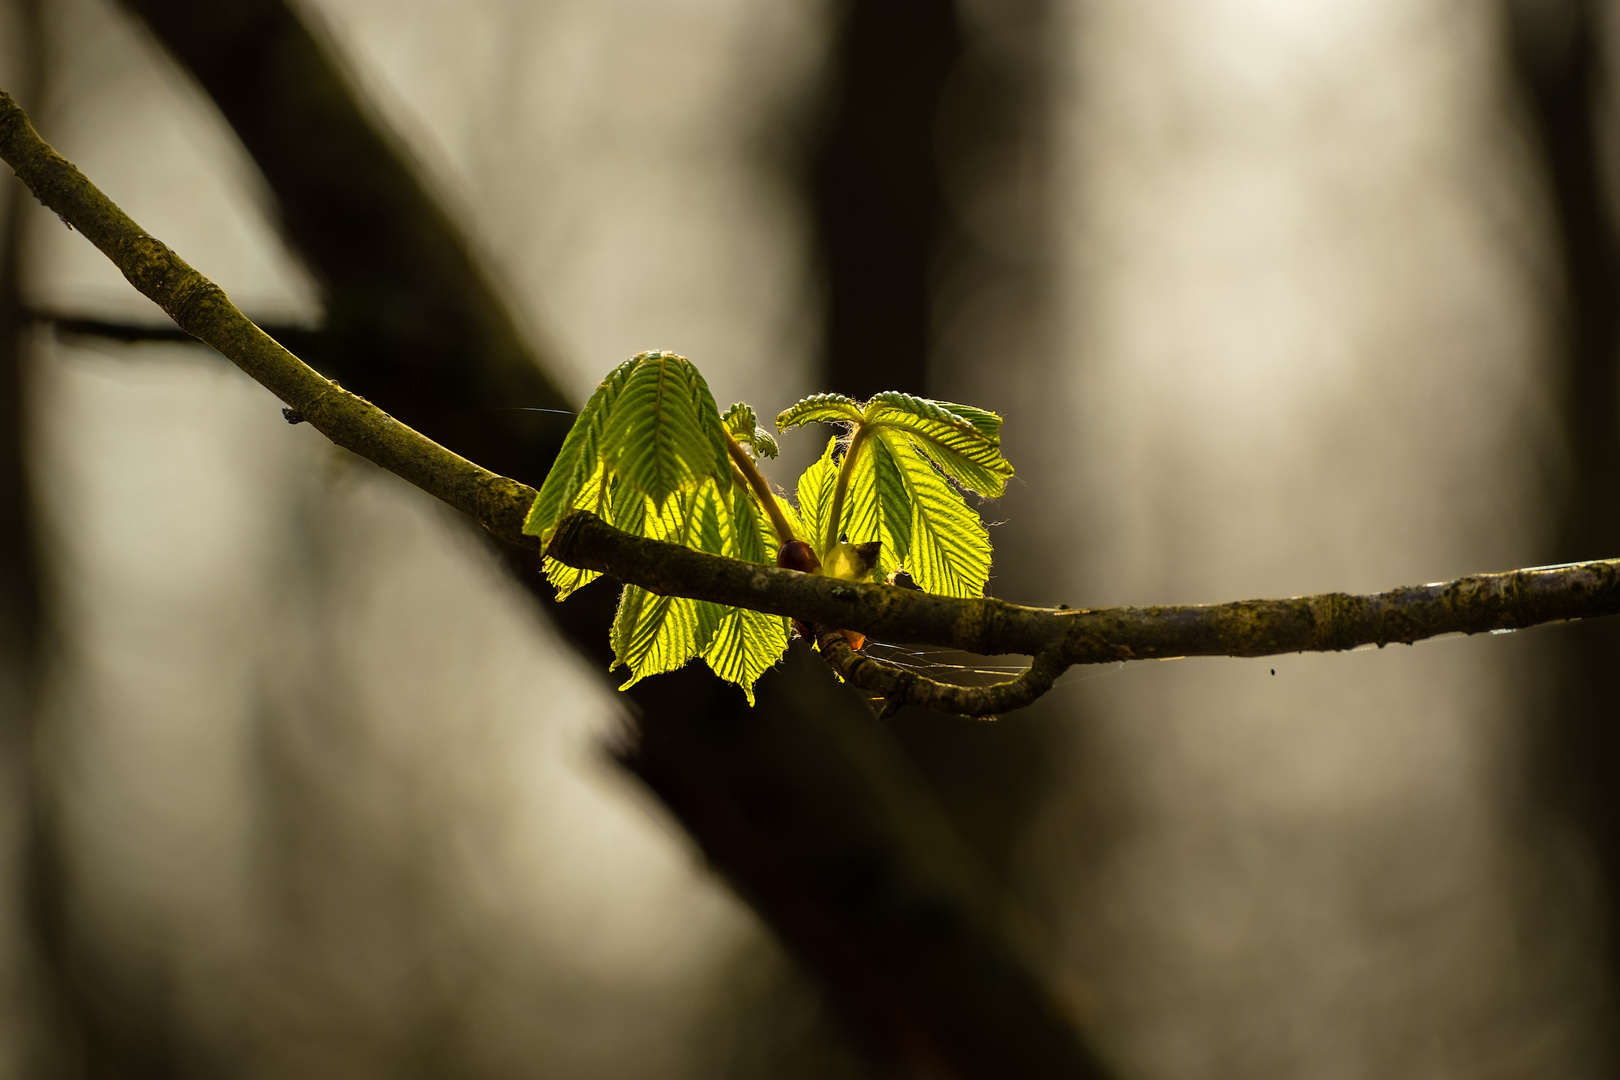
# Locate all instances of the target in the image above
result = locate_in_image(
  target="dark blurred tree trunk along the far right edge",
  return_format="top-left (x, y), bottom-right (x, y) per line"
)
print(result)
top-left (1508, 0), bottom-right (1620, 1049)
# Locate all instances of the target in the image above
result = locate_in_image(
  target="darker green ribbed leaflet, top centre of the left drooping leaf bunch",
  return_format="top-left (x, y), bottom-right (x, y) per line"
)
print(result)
top-left (601, 353), bottom-right (731, 508)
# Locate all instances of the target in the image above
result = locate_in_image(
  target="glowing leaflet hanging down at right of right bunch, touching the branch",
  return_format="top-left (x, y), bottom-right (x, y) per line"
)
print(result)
top-left (886, 439), bottom-right (990, 597)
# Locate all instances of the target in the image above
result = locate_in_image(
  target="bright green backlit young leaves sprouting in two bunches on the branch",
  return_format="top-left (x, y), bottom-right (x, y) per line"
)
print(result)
top-left (523, 351), bottom-right (1013, 703)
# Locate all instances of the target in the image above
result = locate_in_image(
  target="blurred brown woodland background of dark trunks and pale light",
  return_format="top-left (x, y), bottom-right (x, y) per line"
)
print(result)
top-left (0, 0), bottom-right (1620, 1080)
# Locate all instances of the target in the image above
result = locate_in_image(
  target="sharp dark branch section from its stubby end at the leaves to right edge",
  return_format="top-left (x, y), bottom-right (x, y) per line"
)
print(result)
top-left (549, 512), bottom-right (1620, 664)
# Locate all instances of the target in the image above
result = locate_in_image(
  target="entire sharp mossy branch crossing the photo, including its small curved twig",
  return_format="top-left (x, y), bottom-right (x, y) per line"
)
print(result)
top-left (0, 91), bottom-right (1620, 712)
